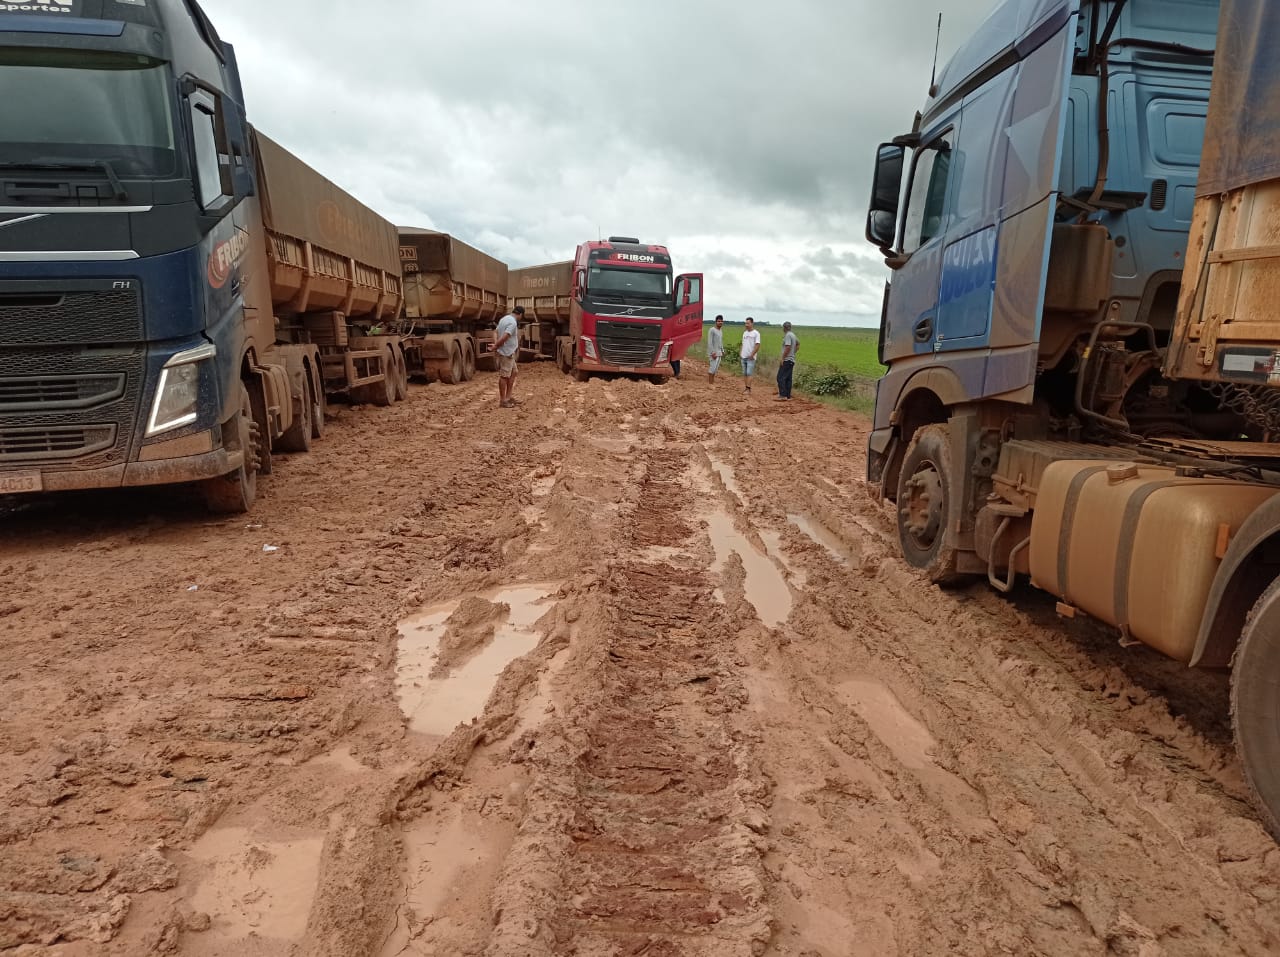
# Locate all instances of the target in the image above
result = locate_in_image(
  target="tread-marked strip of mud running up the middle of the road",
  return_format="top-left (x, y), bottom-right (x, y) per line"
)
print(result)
top-left (486, 445), bottom-right (771, 957)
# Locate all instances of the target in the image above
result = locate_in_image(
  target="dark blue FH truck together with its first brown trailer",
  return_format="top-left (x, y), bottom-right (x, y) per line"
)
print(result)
top-left (0, 0), bottom-right (407, 512)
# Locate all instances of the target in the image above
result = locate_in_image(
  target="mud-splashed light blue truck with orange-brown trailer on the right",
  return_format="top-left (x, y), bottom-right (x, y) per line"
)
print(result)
top-left (867, 0), bottom-right (1280, 838)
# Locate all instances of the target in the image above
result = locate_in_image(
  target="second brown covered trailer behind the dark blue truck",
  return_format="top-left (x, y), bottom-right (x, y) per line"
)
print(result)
top-left (399, 226), bottom-right (507, 383)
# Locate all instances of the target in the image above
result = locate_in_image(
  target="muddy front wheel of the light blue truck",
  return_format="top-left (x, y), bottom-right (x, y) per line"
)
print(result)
top-left (897, 425), bottom-right (963, 585)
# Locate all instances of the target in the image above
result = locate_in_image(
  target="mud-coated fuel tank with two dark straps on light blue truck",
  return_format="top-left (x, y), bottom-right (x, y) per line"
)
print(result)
top-left (1030, 461), bottom-right (1280, 661)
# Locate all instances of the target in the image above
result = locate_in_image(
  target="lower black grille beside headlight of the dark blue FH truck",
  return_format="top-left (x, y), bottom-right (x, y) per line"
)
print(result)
top-left (0, 347), bottom-right (146, 470)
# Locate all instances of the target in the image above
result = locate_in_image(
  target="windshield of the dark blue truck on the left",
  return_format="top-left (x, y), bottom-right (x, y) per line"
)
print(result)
top-left (0, 47), bottom-right (177, 177)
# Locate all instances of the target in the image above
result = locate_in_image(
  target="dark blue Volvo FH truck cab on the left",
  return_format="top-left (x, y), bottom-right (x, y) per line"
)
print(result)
top-left (0, 0), bottom-right (273, 504)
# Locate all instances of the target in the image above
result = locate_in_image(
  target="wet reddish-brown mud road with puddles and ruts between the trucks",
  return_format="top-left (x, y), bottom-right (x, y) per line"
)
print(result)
top-left (0, 367), bottom-right (1280, 957)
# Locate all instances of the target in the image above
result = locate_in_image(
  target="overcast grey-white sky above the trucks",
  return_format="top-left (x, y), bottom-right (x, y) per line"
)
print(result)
top-left (204, 0), bottom-right (995, 324)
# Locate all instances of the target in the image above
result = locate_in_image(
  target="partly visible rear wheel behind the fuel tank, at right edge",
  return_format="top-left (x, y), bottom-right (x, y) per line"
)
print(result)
top-left (1231, 580), bottom-right (1280, 841)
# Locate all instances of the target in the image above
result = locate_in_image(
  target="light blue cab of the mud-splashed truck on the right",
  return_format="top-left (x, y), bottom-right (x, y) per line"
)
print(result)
top-left (867, 0), bottom-right (1231, 500)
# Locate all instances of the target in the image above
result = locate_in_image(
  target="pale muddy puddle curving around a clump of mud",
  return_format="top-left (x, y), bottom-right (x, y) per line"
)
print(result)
top-left (396, 583), bottom-right (559, 736)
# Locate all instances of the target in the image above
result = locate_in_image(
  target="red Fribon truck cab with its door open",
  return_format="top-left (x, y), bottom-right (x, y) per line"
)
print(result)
top-left (570, 237), bottom-right (703, 377)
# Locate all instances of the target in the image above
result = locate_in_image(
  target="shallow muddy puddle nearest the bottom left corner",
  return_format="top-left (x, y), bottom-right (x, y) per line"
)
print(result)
top-left (191, 828), bottom-right (324, 953)
